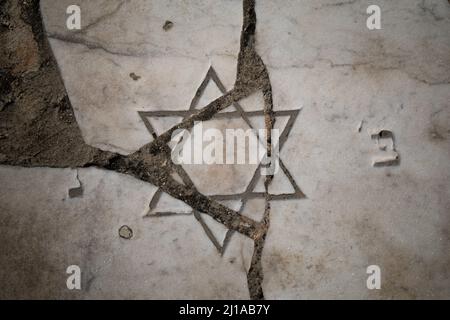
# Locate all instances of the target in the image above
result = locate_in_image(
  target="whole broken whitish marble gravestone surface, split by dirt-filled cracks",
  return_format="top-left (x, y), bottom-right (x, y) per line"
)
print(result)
top-left (0, 0), bottom-right (450, 299)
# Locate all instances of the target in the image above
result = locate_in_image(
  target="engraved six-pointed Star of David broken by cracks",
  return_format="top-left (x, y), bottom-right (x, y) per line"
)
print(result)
top-left (139, 67), bottom-right (305, 255)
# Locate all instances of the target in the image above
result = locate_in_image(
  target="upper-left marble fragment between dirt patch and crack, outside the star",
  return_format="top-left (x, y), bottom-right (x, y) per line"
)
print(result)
top-left (41, 0), bottom-right (242, 154)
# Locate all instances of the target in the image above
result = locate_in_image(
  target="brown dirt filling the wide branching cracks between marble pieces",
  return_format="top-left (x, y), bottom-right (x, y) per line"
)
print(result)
top-left (0, 0), bottom-right (298, 299)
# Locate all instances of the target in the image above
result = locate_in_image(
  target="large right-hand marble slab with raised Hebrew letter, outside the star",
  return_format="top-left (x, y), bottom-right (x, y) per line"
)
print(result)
top-left (257, 0), bottom-right (450, 299)
